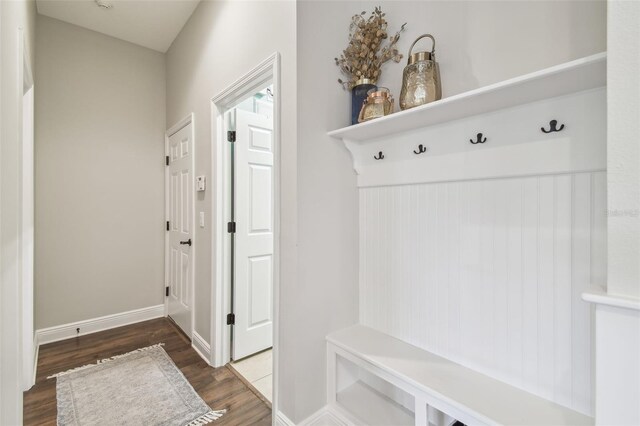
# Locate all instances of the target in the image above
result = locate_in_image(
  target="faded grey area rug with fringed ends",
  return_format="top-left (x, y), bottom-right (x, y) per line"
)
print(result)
top-left (49, 343), bottom-right (225, 426)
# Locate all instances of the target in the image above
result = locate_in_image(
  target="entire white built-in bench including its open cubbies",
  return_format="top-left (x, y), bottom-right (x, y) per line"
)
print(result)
top-left (327, 325), bottom-right (594, 426)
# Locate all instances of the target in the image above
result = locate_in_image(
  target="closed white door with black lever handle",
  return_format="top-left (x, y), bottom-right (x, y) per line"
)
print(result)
top-left (165, 122), bottom-right (194, 337)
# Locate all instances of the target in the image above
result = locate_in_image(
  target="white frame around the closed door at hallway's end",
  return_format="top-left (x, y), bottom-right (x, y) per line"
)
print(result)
top-left (162, 113), bottom-right (197, 341)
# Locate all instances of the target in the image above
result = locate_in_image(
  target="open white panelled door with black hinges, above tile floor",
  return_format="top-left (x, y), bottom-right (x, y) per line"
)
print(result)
top-left (232, 110), bottom-right (274, 360)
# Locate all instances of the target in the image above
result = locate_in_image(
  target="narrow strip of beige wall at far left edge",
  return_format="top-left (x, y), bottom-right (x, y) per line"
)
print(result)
top-left (0, 0), bottom-right (36, 425)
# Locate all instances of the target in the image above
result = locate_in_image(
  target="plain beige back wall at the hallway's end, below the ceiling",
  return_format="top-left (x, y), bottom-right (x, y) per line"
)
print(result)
top-left (35, 16), bottom-right (165, 329)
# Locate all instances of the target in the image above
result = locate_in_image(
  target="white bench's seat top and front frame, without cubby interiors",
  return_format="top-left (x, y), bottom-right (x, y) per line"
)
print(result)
top-left (327, 325), bottom-right (594, 425)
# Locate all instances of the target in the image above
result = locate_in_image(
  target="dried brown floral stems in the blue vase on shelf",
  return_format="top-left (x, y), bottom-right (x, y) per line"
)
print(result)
top-left (334, 6), bottom-right (407, 90)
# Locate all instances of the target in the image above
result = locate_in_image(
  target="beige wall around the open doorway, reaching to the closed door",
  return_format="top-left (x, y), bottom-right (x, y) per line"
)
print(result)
top-left (166, 0), bottom-right (296, 356)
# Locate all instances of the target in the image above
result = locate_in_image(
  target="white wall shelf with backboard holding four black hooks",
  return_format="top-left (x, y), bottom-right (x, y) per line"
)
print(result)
top-left (329, 53), bottom-right (606, 187)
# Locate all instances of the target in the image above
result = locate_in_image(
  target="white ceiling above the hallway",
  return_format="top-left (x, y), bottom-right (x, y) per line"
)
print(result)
top-left (36, 0), bottom-right (200, 53)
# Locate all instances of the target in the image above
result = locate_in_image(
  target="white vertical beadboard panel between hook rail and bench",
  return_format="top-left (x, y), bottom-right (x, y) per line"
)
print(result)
top-left (360, 172), bottom-right (606, 415)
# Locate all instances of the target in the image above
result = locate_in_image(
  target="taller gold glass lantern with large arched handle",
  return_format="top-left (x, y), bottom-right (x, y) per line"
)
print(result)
top-left (400, 34), bottom-right (442, 110)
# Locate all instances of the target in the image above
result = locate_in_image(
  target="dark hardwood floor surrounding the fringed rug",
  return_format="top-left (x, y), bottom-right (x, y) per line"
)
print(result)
top-left (24, 318), bottom-right (271, 426)
